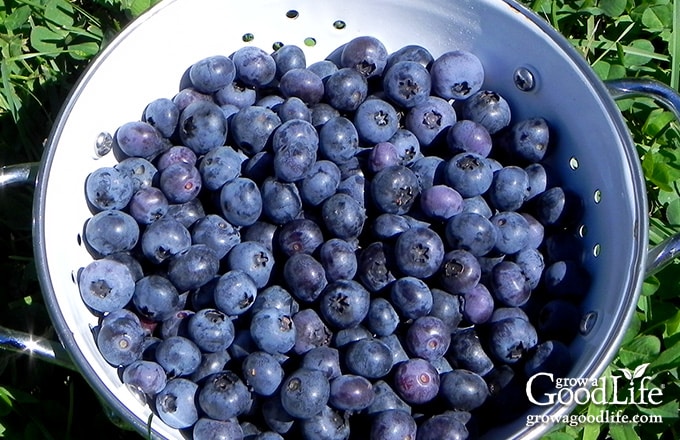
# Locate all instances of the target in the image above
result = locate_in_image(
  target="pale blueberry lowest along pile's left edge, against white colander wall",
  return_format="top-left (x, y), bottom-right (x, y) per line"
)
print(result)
top-left (155, 378), bottom-right (198, 429)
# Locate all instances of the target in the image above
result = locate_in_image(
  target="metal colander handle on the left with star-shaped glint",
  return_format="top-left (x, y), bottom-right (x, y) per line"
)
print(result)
top-left (0, 162), bottom-right (75, 370)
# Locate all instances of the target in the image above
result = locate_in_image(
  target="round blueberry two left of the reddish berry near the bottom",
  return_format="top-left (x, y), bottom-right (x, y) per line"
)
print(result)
top-left (281, 368), bottom-right (330, 419)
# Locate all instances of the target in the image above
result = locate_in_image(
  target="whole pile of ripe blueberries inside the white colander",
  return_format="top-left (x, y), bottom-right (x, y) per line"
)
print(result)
top-left (78, 36), bottom-right (589, 440)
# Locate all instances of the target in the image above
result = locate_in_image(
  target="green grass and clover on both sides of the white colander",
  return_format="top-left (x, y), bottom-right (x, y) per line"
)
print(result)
top-left (0, 0), bottom-right (680, 440)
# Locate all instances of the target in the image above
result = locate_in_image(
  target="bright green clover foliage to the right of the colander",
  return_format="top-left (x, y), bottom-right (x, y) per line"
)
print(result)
top-left (527, 0), bottom-right (680, 440)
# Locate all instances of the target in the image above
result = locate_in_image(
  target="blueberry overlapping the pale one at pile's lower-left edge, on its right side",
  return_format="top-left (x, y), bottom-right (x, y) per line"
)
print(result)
top-left (197, 370), bottom-right (253, 420)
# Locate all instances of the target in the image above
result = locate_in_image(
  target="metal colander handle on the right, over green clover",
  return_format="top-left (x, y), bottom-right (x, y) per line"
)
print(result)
top-left (605, 78), bottom-right (680, 276)
